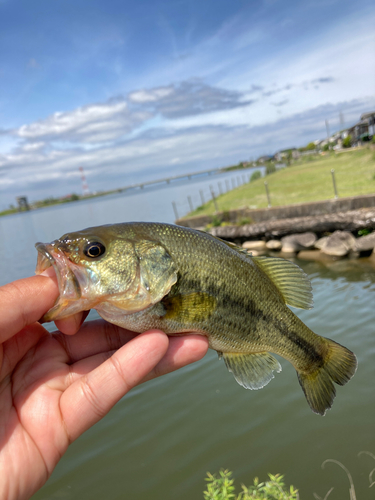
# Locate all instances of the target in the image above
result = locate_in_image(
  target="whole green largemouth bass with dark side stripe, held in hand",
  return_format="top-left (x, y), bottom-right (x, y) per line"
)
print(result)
top-left (36, 222), bottom-right (357, 415)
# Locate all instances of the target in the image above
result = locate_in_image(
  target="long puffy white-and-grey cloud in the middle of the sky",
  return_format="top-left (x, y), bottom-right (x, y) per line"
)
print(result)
top-left (8, 79), bottom-right (252, 147)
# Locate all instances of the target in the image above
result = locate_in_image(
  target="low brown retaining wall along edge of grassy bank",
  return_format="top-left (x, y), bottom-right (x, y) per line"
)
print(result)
top-left (176, 194), bottom-right (375, 228)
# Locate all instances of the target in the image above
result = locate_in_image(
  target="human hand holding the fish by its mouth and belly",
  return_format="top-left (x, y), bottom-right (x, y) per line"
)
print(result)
top-left (0, 276), bottom-right (208, 500)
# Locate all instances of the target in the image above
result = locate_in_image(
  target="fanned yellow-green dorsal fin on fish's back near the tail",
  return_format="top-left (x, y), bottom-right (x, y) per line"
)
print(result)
top-left (252, 257), bottom-right (314, 309)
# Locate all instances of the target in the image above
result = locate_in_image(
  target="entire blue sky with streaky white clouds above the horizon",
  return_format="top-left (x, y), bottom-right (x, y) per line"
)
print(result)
top-left (0, 0), bottom-right (375, 209)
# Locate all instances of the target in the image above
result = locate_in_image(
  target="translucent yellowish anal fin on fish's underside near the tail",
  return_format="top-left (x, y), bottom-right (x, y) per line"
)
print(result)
top-left (222, 352), bottom-right (281, 390)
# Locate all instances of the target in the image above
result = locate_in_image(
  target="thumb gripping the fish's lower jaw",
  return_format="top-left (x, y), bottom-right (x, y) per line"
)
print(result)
top-left (0, 276), bottom-right (59, 342)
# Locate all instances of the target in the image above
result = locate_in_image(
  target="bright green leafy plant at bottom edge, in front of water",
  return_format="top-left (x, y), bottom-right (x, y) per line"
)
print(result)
top-left (203, 469), bottom-right (299, 500)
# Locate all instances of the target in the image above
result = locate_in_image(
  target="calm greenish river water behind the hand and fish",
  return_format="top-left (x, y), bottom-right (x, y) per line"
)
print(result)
top-left (0, 173), bottom-right (375, 500)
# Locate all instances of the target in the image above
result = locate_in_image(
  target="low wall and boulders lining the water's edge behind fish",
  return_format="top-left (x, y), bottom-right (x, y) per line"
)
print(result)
top-left (176, 195), bottom-right (375, 263)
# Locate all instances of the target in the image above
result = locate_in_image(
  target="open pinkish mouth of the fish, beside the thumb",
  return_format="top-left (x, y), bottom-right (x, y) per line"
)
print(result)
top-left (35, 242), bottom-right (87, 323)
